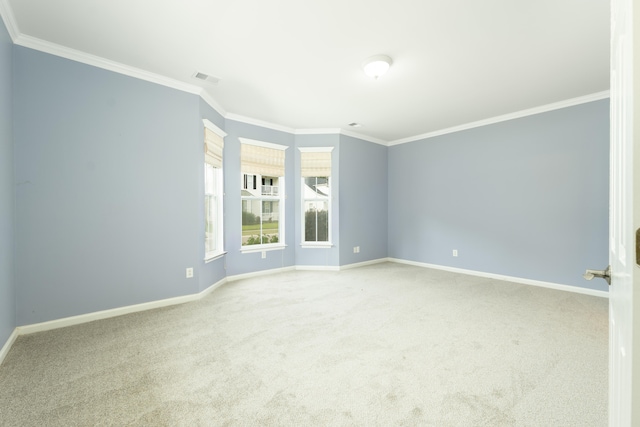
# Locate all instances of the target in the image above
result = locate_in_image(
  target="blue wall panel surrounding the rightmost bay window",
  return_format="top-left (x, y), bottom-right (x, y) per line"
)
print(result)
top-left (294, 134), bottom-right (340, 267)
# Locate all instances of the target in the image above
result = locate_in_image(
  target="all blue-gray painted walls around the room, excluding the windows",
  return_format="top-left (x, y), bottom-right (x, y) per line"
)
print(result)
top-left (0, 36), bottom-right (609, 332)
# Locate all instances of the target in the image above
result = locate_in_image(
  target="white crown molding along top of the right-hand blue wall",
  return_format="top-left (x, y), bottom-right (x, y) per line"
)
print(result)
top-left (388, 90), bottom-right (609, 147)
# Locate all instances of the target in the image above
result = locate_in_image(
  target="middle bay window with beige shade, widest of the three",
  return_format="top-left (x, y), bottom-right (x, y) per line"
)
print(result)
top-left (240, 138), bottom-right (287, 251)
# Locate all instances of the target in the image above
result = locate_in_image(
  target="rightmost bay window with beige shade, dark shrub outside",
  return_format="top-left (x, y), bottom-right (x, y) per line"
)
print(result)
top-left (300, 147), bottom-right (333, 246)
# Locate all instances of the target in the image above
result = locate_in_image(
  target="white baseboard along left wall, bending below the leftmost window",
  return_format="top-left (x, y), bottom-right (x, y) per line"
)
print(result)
top-left (16, 279), bottom-right (227, 335)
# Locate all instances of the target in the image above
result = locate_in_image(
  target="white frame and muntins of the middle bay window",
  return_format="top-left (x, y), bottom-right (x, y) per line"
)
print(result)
top-left (238, 137), bottom-right (289, 253)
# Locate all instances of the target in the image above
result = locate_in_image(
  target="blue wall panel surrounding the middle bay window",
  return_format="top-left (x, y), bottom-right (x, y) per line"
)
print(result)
top-left (223, 120), bottom-right (295, 276)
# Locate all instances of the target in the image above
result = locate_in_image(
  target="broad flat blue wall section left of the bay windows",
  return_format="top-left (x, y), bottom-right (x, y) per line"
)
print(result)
top-left (14, 46), bottom-right (203, 325)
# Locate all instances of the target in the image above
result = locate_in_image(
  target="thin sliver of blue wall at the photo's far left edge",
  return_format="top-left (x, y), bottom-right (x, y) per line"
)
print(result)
top-left (0, 19), bottom-right (16, 348)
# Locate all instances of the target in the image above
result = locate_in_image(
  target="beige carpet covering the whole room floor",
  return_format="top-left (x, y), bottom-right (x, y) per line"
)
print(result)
top-left (0, 263), bottom-right (608, 426)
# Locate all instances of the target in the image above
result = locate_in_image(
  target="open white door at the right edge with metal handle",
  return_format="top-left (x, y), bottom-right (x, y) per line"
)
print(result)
top-left (609, 0), bottom-right (640, 426)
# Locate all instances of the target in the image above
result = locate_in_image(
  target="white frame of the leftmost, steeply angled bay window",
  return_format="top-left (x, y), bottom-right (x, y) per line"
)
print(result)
top-left (202, 119), bottom-right (227, 263)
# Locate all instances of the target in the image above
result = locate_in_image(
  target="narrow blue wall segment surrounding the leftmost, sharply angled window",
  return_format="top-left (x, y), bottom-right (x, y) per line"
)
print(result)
top-left (194, 98), bottom-right (227, 291)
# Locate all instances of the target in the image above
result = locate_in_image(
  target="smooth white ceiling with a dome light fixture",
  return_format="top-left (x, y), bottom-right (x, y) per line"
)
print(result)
top-left (0, 0), bottom-right (609, 142)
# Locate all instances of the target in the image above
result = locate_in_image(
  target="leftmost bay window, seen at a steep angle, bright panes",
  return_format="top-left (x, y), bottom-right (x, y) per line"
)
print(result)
top-left (204, 120), bottom-right (226, 260)
